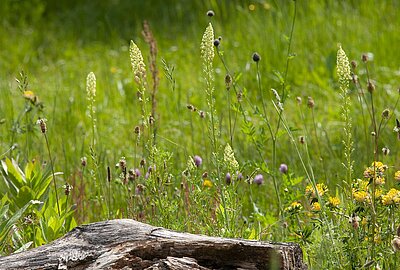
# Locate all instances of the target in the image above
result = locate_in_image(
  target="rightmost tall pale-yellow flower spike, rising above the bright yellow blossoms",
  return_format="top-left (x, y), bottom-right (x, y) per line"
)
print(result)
top-left (336, 47), bottom-right (354, 187)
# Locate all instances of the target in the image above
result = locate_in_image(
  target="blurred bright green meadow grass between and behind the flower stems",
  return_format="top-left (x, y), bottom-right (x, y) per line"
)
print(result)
top-left (0, 0), bottom-right (400, 269)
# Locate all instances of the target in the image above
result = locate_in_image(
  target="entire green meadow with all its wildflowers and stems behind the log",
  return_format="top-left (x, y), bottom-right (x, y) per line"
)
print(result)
top-left (0, 1), bottom-right (400, 269)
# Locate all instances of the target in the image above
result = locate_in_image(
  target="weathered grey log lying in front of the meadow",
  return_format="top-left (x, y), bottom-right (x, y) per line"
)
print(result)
top-left (0, 219), bottom-right (307, 270)
